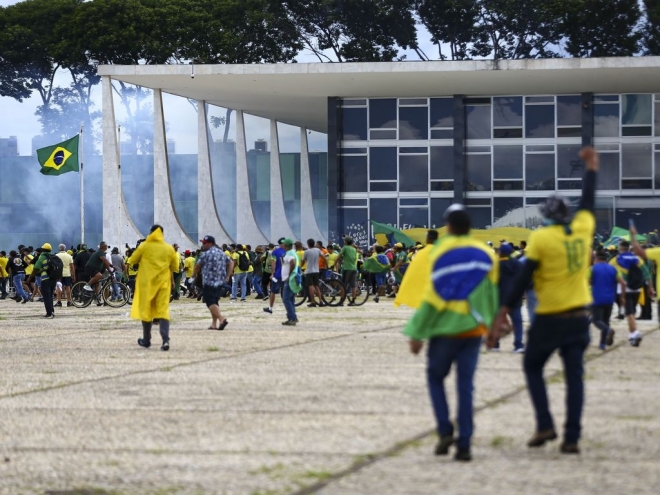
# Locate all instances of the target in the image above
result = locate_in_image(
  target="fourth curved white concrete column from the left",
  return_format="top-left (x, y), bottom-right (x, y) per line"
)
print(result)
top-left (236, 110), bottom-right (268, 246)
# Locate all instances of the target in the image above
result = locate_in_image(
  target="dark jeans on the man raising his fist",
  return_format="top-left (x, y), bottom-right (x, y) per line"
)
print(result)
top-left (523, 315), bottom-right (589, 443)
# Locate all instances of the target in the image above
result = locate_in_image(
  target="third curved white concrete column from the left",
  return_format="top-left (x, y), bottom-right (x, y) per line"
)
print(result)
top-left (197, 101), bottom-right (233, 244)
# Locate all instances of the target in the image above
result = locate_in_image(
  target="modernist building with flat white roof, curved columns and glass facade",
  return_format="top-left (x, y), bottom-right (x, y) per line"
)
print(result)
top-left (99, 57), bottom-right (660, 252)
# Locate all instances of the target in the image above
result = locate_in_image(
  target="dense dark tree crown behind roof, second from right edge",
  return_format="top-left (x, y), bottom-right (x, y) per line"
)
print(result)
top-left (563, 0), bottom-right (642, 57)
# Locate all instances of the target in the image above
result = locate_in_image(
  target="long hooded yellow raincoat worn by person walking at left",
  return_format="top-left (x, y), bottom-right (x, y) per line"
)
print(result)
top-left (128, 229), bottom-right (179, 321)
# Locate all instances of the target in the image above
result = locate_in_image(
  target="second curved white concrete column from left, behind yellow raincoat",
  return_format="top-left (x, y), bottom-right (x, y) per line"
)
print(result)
top-left (154, 89), bottom-right (197, 249)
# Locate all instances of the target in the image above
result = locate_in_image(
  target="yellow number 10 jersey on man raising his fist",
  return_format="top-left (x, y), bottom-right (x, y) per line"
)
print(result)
top-left (525, 210), bottom-right (596, 314)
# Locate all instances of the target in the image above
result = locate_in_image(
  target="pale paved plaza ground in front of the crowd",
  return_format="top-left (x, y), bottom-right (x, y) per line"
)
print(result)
top-left (0, 299), bottom-right (660, 495)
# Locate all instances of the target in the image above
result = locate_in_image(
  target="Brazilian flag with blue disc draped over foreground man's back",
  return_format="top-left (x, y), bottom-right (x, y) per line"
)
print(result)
top-left (403, 236), bottom-right (499, 340)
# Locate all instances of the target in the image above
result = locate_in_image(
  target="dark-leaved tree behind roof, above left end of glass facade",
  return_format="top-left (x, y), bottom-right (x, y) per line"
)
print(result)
top-left (282, 0), bottom-right (427, 62)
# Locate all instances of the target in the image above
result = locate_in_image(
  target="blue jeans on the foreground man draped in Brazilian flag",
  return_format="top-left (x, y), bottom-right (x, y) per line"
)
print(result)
top-left (426, 337), bottom-right (481, 449)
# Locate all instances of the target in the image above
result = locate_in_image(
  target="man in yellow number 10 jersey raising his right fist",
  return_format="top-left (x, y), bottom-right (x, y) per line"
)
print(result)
top-left (488, 147), bottom-right (598, 454)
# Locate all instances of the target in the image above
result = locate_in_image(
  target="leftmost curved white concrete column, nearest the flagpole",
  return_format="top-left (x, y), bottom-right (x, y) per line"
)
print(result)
top-left (101, 76), bottom-right (142, 246)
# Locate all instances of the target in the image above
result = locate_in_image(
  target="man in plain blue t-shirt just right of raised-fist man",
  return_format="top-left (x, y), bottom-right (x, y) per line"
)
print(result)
top-left (591, 251), bottom-right (626, 351)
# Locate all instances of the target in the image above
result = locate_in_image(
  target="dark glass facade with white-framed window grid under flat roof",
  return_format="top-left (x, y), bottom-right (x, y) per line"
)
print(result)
top-left (337, 94), bottom-right (660, 245)
